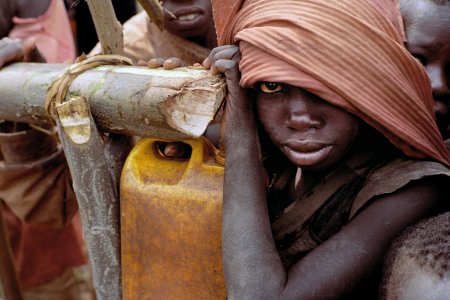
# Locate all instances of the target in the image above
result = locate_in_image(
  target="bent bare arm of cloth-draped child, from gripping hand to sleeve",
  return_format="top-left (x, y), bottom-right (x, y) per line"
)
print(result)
top-left (205, 47), bottom-right (442, 299)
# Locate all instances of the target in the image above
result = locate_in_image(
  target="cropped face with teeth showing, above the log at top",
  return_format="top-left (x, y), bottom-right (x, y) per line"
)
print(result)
top-left (162, 0), bottom-right (214, 38)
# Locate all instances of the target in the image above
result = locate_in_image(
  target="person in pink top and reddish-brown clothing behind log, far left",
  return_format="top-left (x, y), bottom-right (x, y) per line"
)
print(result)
top-left (0, 0), bottom-right (87, 299)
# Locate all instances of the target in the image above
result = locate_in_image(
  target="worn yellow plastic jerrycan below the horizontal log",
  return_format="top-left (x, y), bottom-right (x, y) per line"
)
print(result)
top-left (120, 138), bottom-right (226, 300)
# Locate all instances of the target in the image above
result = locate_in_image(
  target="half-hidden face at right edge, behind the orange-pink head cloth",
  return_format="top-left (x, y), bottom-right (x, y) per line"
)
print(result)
top-left (400, 0), bottom-right (450, 138)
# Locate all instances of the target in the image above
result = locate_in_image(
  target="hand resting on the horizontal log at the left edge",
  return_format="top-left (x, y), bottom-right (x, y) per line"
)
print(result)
top-left (0, 37), bottom-right (45, 68)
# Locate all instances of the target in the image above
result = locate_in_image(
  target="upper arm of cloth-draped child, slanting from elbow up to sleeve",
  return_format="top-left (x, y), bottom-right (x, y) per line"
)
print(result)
top-left (280, 178), bottom-right (444, 299)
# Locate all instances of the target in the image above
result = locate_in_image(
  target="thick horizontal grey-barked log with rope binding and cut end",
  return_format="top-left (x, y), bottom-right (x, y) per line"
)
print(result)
top-left (0, 63), bottom-right (226, 140)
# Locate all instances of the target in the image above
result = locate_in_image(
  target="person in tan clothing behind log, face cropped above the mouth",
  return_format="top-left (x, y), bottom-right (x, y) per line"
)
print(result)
top-left (91, 0), bottom-right (217, 65)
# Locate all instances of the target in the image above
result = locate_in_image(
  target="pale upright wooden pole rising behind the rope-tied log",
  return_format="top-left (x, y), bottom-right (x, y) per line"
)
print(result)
top-left (86, 0), bottom-right (124, 55)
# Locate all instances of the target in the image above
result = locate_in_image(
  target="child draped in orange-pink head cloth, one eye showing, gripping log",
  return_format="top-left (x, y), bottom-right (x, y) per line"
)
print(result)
top-left (204, 0), bottom-right (450, 299)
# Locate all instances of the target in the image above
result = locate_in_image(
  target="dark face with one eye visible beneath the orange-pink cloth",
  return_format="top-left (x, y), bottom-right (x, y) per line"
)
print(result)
top-left (256, 82), bottom-right (358, 171)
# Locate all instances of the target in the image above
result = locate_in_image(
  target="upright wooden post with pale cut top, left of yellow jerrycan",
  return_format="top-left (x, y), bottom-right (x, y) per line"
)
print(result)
top-left (56, 97), bottom-right (122, 300)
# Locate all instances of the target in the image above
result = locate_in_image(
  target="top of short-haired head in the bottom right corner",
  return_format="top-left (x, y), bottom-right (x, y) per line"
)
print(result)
top-left (383, 213), bottom-right (450, 300)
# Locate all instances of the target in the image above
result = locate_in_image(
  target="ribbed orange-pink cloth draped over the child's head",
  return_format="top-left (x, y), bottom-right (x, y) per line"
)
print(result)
top-left (212, 0), bottom-right (450, 166)
